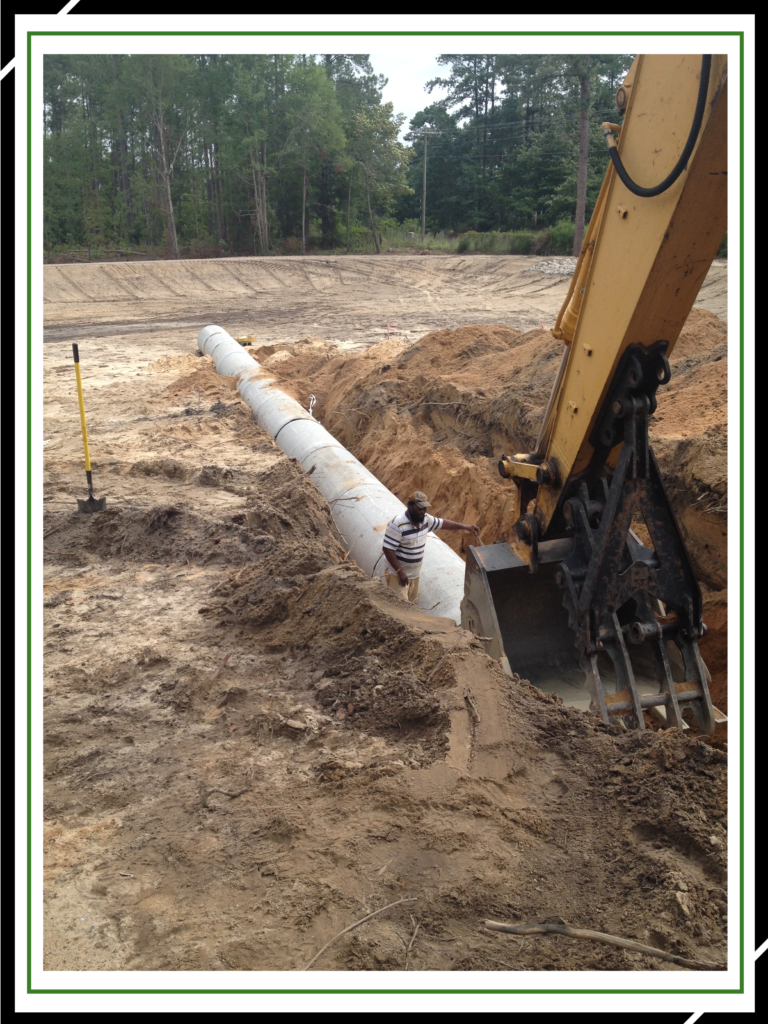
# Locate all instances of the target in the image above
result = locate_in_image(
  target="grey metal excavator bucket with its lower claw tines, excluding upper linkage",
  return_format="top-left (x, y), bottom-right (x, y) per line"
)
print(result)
top-left (462, 530), bottom-right (725, 733)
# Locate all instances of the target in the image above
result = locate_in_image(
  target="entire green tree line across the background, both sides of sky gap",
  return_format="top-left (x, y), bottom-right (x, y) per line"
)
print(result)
top-left (43, 54), bottom-right (631, 259)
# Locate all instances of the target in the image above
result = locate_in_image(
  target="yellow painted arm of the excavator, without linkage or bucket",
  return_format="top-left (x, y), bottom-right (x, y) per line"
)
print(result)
top-left (537, 54), bottom-right (728, 520)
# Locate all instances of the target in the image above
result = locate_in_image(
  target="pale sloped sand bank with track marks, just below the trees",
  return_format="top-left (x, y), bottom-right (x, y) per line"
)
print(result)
top-left (45, 255), bottom-right (727, 344)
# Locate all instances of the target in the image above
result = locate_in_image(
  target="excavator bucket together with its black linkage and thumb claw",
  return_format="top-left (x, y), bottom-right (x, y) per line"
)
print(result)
top-left (462, 341), bottom-right (716, 735)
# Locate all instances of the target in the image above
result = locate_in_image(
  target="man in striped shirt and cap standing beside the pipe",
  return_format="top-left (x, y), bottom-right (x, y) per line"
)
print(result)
top-left (382, 490), bottom-right (480, 604)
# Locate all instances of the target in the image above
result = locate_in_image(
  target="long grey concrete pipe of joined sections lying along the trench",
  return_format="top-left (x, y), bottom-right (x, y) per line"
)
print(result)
top-left (198, 326), bottom-right (464, 623)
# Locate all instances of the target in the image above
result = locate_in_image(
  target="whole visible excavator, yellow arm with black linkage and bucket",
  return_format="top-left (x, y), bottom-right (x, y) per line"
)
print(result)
top-left (462, 54), bottom-right (728, 736)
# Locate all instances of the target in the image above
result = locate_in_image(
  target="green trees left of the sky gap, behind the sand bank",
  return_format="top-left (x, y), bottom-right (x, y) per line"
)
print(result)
top-left (43, 54), bottom-right (409, 259)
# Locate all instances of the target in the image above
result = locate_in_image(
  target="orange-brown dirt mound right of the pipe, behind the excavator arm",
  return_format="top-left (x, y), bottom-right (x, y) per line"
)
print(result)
top-left (254, 309), bottom-right (728, 720)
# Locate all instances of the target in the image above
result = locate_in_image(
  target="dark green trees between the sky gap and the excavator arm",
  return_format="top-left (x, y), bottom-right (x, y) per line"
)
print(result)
top-left (397, 53), bottom-right (632, 235)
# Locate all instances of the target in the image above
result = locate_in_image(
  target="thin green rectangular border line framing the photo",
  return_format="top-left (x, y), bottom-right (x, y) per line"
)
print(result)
top-left (26, 30), bottom-right (744, 995)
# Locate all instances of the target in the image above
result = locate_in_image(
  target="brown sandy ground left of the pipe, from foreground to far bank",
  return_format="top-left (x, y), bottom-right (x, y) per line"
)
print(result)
top-left (43, 251), bottom-right (727, 971)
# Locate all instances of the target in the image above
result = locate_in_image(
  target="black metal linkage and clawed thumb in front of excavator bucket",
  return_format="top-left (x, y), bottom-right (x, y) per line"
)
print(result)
top-left (555, 342), bottom-right (715, 734)
